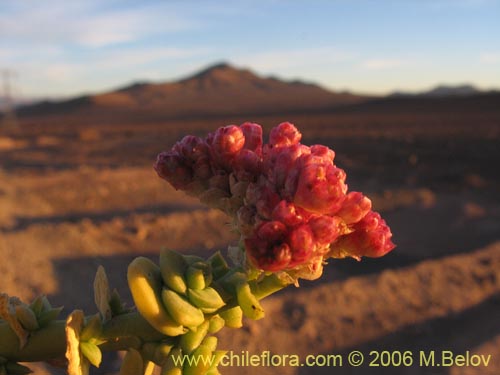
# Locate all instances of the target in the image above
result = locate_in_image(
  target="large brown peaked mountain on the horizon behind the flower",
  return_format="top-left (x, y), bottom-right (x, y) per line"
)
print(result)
top-left (19, 63), bottom-right (367, 118)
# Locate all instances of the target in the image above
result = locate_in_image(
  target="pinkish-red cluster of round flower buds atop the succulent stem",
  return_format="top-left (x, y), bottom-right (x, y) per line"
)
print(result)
top-left (154, 122), bottom-right (394, 279)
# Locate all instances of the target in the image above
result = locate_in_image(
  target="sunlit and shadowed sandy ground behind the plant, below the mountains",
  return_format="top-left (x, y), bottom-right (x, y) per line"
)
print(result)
top-left (0, 111), bottom-right (500, 375)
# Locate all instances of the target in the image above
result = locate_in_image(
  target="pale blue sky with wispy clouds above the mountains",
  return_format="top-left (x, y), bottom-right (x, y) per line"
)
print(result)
top-left (0, 0), bottom-right (500, 98)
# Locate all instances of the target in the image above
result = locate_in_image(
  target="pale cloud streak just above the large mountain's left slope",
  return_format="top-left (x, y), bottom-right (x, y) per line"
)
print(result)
top-left (16, 47), bottom-right (211, 96)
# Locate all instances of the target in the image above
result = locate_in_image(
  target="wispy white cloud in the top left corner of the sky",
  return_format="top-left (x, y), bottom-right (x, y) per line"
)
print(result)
top-left (0, 1), bottom-right (201, 47)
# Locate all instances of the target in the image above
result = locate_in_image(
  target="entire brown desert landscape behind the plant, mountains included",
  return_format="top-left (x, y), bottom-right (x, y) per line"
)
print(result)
top-left (0, 66), bottom-right (500, 375)
